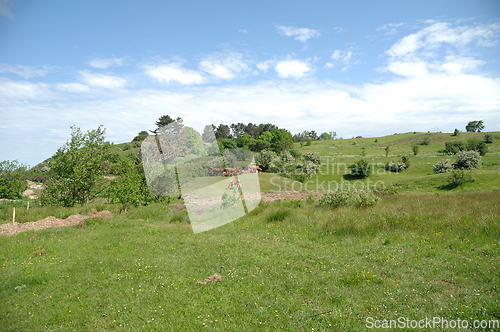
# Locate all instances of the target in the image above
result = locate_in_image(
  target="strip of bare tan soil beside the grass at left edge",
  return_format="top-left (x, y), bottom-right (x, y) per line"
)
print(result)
top-left (0, 210), bottom-right (111, 236)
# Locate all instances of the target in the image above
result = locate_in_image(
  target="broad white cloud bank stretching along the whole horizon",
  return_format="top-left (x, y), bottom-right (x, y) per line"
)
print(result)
top-left (0, 69), bottom-right (500, 165)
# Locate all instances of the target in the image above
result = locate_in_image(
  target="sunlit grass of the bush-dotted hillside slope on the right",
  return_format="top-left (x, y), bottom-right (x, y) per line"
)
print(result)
top-left (292, 132), bottom-right (500, 193)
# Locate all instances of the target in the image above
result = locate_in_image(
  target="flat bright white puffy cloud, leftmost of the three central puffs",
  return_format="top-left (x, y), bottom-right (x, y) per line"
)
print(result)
top-left (144, 62), bottom-right (205, 85)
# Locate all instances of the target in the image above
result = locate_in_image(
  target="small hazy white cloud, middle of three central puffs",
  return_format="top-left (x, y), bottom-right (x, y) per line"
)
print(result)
top-left (200, 52), bottom-right (250, 80)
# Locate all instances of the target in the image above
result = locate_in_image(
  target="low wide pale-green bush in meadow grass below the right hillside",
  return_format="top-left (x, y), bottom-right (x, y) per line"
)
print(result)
top-left (319, 189), bottom-right (380, 208)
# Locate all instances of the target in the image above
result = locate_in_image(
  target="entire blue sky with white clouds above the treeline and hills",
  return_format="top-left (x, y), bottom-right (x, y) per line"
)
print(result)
top-left (0, 0), bottom-right (500, 166)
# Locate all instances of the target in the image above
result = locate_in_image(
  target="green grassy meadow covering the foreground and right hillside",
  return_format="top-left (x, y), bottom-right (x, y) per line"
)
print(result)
top-left (0, 133), bottom-right (500, 331)
